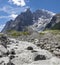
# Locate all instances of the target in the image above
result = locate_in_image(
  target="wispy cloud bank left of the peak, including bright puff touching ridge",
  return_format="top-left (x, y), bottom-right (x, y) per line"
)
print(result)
top-left (0, 5), bottom-right (28, 20)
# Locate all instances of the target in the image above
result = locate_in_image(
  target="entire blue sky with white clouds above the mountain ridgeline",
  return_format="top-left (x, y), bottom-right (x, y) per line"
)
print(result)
top-left (0, 0), bottom-right (60, 30)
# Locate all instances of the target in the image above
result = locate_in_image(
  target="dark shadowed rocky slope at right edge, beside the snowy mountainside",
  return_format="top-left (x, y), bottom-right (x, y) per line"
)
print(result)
top-left (46, 14), bottom-right (60, 29)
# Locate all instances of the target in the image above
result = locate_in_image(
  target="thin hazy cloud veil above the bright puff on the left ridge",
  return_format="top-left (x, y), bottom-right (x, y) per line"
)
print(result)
top-left (0, 5), bottom-right (28, 15)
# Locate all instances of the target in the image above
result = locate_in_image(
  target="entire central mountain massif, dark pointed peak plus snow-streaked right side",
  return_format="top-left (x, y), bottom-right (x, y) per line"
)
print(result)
top-left (2, 8), bottom-right (54, 32)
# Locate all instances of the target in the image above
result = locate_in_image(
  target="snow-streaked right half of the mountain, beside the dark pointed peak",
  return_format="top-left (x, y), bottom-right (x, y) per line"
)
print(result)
top-left (32, 9), bottom-right (55, 32)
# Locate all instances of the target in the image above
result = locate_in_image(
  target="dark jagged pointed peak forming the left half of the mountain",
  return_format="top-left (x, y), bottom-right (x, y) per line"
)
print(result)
top-left (2, 9), bottom-right (33, 32)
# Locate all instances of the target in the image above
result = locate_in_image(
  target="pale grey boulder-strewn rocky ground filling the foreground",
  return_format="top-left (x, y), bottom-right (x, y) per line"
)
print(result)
top-left (0, 31), bottom-right (60, 65)
